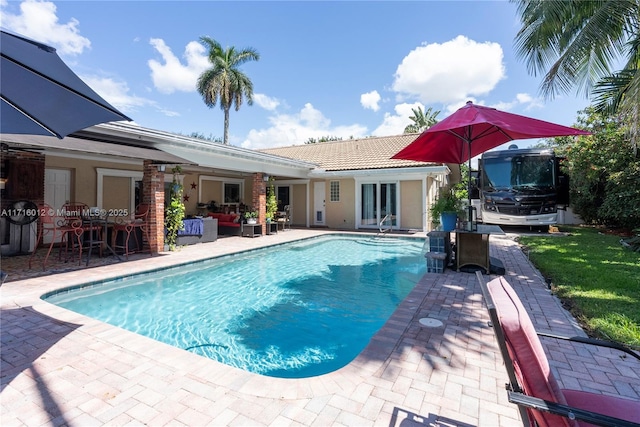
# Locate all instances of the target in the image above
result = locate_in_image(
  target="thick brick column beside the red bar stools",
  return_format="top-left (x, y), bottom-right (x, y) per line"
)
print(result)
top-left (142, 160), bottom-right (164, 254)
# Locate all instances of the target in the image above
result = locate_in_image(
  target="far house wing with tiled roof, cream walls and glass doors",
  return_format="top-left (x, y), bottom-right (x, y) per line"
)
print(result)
top-left (261, 134), bottom-right (460, 231)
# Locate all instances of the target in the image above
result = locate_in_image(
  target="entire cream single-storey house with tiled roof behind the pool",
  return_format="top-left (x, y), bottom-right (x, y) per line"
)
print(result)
top-left (0, 122), bottom-right (459, 254)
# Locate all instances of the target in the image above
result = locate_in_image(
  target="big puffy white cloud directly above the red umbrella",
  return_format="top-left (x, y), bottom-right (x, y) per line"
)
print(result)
top-left (392, 36), bottom-right (505, 104)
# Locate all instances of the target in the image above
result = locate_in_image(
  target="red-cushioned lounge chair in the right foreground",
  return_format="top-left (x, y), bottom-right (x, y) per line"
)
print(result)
top-left (476, 271), bottom-right (640, 427)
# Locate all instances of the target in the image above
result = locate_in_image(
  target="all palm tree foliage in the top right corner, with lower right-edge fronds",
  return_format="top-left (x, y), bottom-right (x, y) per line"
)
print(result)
top-left (512, 0), bottom-right (640, 153)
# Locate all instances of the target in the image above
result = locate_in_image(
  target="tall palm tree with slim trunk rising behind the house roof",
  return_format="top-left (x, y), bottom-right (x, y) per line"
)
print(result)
top-left (197, 36), bottom-right (260, 145)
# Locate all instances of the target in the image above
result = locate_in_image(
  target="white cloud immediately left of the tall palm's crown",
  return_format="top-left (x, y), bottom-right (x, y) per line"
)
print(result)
top-left (147, 39), bottom-right (210, 94)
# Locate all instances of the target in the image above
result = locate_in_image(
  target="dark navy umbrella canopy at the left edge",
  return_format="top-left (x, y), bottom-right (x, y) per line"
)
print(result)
top-left (0, 30), bottom-right (131, 138)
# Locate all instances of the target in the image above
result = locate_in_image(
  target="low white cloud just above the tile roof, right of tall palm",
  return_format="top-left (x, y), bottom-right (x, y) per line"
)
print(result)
top-left (241, 103), bottom-right (367, 149)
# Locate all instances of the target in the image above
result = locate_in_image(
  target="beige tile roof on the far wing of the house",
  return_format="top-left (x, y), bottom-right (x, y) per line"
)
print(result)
top-left (258, 133), bottom-right (439, 171)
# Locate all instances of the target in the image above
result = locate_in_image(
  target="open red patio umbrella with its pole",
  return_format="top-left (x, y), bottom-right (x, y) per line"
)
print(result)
top-left (391, 101), bottom-right (590, 211)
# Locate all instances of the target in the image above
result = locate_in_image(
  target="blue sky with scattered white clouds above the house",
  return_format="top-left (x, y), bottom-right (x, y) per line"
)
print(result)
top-left (0, 0), bottom-right (588, 149)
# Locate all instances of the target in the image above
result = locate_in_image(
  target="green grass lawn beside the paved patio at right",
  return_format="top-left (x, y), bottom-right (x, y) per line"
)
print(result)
top-left (519, 227), bottom-right (640, 348)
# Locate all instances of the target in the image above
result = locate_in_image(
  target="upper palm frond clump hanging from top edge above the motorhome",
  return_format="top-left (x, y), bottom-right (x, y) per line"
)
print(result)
top-left (515, 0), bottom-right (638, 99)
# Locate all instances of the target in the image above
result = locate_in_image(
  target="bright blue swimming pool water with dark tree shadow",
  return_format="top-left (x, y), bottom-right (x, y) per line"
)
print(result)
top-left (43, 235), bottom-right (426, 378)
